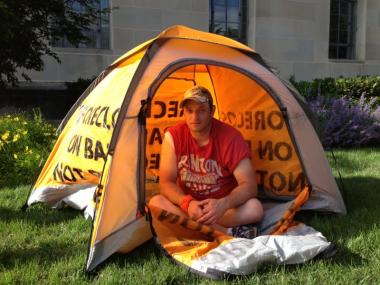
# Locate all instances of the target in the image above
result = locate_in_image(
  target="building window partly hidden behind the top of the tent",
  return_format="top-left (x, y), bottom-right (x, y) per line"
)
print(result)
top-left (209, 0), bottom-right (247, 43)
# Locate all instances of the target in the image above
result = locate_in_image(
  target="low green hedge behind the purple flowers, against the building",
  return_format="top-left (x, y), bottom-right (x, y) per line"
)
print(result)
top-left (290, 76), bottom-right (380, 105)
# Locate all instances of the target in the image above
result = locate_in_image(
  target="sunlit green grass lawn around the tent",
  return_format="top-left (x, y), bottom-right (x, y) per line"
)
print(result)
top-left (0, 148), bottom-right (380, 285)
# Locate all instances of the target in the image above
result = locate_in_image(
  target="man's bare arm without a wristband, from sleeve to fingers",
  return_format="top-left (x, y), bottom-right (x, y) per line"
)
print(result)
top-left (198, 158), bottom-right (257, 224)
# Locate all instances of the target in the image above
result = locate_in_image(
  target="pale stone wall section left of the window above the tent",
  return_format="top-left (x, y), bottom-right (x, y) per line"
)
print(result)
top-left (27, 0), bottom-right (209, 84)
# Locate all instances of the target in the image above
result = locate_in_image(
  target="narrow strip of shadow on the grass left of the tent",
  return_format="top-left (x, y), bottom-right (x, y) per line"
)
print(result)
top-left (0, 205), bottom-right (83, 225)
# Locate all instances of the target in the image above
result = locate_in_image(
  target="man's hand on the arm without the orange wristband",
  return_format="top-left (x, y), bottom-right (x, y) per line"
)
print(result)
top-left (197, 198), bottom-right (229, 225)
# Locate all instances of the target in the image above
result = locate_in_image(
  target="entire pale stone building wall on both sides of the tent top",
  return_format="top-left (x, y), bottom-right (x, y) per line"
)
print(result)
top-left (21, 0), bottom-right (380, 84)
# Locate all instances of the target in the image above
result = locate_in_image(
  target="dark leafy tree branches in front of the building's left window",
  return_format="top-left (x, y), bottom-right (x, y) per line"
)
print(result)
top-left (0, 0), bottom-right (108, 88)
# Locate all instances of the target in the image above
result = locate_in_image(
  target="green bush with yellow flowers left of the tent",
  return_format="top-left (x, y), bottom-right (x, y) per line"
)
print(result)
top-left (0, 110), bottom-right (56, 187)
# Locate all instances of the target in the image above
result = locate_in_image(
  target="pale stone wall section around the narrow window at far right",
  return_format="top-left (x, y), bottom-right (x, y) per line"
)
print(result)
top-left (252, 0), bottom-right (380, 80)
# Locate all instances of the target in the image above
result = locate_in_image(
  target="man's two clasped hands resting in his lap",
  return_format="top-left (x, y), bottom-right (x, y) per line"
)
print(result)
top-left (188, 198), bottom-right (228, 225)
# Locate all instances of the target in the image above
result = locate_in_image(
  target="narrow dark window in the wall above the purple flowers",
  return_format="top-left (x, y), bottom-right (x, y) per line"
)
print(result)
top-left (329, 0), bottom-right (357, 59)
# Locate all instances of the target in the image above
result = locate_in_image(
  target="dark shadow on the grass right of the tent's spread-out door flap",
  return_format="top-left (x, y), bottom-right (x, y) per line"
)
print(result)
top-left (295, 177), bottom-right (380, 266)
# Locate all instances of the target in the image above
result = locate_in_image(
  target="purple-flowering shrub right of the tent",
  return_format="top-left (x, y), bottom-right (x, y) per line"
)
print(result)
top-left (309, 95), bottom-right (380, 147)
